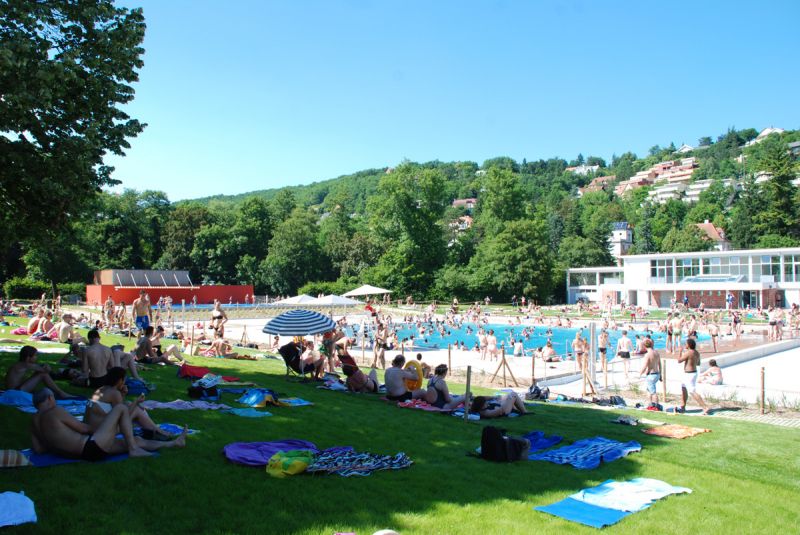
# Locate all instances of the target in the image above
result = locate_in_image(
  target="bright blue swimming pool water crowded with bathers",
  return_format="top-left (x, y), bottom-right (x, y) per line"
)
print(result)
top-left (348, 322), bottom-right (709, 359)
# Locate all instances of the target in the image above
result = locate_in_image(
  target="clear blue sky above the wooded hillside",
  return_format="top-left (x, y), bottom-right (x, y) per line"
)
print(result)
top-left (110, 0), bottom-right (800, 200)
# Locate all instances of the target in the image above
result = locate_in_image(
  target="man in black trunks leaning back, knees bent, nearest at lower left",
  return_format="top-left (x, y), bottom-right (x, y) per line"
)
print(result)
top-left (31, 388), bottom-right (187, 462)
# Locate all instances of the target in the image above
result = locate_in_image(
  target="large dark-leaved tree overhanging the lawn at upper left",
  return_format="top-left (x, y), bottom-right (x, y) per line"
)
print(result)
top-left (0, 0), bottom-right (145, 253)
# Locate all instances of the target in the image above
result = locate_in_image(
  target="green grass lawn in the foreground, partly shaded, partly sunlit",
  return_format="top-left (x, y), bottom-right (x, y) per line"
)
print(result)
top-left (0, 322), bottom-right (800, 535)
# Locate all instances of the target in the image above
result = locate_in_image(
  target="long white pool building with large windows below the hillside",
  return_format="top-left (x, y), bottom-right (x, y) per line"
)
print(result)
top-left (566, 247), bottom-right (800, 308)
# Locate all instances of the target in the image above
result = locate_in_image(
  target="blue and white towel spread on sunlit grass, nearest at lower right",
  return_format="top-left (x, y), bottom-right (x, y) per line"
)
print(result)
top-left (534, 477), bottom-right (692, 529)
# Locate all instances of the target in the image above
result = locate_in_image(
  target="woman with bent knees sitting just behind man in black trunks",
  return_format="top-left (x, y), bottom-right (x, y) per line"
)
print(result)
top-left (83, 368), bottom-right (172, 440)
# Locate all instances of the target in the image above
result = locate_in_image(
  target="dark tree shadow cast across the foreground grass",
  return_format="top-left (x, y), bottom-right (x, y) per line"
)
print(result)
top-left (0, 352), bottom-right (700, 534)
